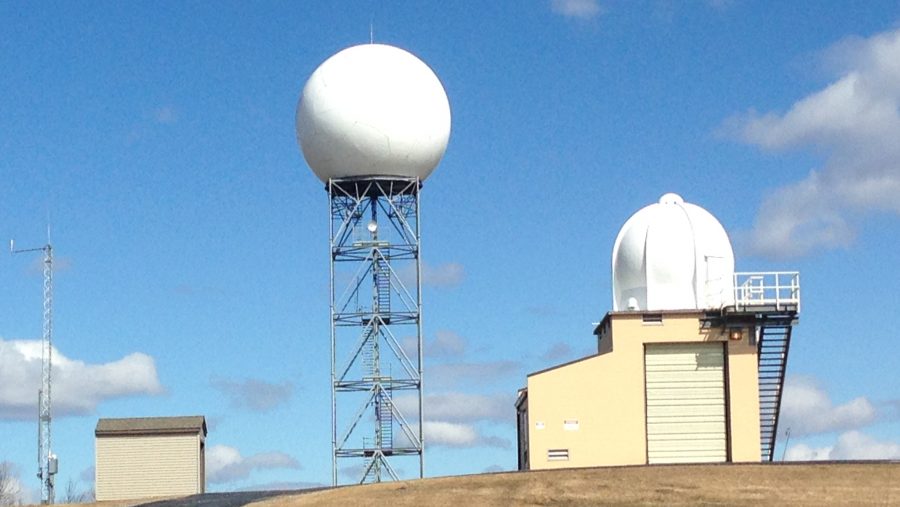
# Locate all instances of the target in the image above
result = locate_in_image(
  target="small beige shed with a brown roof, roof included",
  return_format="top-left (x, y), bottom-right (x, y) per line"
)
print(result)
top-left (94, 416), bottom-right (206, 501)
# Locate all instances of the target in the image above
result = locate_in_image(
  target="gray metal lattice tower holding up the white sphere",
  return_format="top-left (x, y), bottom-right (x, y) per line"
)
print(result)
top-left (327, 177), bottom-right (425, 485)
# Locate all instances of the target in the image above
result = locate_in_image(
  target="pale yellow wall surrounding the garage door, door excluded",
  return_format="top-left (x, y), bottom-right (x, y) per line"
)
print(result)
top-left (527, 312), bottom-right (760, 469)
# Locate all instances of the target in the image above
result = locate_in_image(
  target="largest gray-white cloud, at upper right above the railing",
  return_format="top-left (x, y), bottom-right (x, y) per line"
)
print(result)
top-left (729, 29), bottom-right (900, 257)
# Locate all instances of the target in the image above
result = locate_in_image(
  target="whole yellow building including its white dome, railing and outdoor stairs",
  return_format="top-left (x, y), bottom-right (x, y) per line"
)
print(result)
top-left (516, 194), bottom-right (800, 470)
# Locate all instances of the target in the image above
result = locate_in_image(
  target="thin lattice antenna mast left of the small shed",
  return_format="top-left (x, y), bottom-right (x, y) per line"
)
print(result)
top-left (9, 235), bottom-right (58, 504)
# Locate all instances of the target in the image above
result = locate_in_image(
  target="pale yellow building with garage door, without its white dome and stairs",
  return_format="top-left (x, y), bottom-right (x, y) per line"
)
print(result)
top-left (516, 311), bottom-right (772, 469)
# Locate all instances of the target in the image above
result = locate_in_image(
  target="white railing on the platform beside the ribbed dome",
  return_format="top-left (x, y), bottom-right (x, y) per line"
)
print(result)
top-left (734, 271), bottom-right (800, 313)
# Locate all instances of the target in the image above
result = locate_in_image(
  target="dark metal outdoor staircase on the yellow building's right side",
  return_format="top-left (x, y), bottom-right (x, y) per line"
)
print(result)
top-left (757, 315), bottom-right (794, 461)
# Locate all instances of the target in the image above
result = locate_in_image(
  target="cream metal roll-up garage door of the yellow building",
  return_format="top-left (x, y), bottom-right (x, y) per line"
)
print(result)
top-left (644, 343), bottom-right (728, 463)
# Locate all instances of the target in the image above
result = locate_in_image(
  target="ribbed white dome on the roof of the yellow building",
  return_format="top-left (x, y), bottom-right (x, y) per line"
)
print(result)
top-left (612, 194), bottom-right (734, 311)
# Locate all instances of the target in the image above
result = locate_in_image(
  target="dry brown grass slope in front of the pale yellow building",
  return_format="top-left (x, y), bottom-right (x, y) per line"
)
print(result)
top-left (251, 463), bottom-right (900, 507)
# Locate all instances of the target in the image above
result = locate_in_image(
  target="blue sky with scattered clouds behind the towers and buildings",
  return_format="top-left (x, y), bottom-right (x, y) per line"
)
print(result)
top-left (0, 0), bottom-right (900, 498)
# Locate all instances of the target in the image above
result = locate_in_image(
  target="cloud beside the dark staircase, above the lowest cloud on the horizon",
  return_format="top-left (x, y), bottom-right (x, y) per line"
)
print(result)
top-left (779, 376), bottom-right (878, 437)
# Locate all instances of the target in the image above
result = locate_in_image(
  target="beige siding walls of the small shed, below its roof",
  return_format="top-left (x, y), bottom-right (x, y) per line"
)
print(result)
top-left (95, 434), bottom-right (205, 501)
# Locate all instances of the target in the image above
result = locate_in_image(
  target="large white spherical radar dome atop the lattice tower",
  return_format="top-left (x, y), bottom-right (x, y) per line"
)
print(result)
top-left (297, 44), bottom-right (450, 182)
